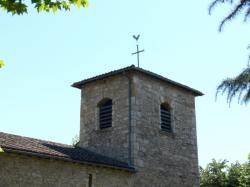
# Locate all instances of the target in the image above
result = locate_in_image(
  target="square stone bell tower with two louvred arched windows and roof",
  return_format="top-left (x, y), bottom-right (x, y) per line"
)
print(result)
top-left (72, 66), bottom-right (203, 187)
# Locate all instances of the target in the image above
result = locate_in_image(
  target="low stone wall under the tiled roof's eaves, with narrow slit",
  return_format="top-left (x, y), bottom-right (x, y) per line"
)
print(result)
top-left (0, 153), bottom-right (133, 187)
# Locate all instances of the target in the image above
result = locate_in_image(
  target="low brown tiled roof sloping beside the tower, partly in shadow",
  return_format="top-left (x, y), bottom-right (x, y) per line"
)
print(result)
top-left (0, 132), bottom-right (134, 172)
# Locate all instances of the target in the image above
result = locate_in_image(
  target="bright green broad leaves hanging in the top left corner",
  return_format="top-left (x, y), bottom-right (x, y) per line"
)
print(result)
top-left (0, 0), bottom-right (88, 15)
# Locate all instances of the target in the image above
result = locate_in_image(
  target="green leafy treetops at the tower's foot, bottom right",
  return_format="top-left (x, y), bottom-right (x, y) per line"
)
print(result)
top-left (200, 155), bottom-right (250, 187)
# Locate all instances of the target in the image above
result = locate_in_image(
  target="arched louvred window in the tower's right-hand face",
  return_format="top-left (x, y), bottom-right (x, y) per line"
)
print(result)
top-left (161, 104), bottom-right (172, 132)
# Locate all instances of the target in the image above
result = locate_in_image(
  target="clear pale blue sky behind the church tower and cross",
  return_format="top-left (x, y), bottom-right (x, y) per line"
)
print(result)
top-left (0, 0), bottom-right (250, 166)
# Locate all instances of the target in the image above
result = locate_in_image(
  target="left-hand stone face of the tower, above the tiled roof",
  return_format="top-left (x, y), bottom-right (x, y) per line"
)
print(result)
top-left (79, 75), bottom-right (129, 162)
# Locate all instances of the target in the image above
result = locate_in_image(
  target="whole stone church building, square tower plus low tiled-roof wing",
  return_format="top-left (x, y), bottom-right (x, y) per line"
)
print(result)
top-left (0, 65), bottom-right (203, 187)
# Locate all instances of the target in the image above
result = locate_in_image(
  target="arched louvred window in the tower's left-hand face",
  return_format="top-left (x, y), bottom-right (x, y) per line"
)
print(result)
top-left (99, 100), bottom-right (112, 129)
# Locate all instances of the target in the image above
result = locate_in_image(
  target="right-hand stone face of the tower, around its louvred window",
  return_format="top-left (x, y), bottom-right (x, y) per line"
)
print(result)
top-left (133, 73), bottom-right (199, 187)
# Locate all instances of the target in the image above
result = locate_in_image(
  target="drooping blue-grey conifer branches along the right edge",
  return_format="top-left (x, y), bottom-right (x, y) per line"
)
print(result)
top-left (209, 0), bottom-right (250, 104)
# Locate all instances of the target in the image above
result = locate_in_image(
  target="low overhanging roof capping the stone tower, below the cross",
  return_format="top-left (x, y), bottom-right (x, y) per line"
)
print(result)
top-left (72, 65), bottom-right (203, 96)
